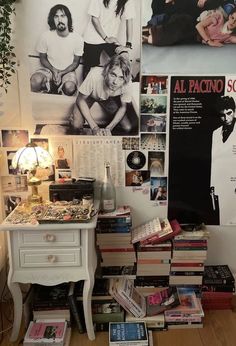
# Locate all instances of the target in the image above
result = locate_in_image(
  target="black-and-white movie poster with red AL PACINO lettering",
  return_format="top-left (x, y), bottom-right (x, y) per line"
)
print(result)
top-left (168, 76), bottom-right (236, 225)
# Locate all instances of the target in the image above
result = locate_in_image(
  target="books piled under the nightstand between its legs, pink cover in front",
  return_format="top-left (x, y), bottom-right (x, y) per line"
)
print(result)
top-left (23, 283), bottom-right (71, 346)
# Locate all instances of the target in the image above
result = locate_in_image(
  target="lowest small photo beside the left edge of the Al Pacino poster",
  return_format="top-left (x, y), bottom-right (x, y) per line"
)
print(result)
top-left (150, 177), bottom-right (167, 205)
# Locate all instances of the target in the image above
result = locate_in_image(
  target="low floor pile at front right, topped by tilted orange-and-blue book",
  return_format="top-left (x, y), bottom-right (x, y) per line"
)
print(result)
top-left (164, 287), bottom-right (204, 329)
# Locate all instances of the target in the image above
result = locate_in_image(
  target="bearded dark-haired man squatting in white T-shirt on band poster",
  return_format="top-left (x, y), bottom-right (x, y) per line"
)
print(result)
top-left (30, 4), bottom-right (84, 96)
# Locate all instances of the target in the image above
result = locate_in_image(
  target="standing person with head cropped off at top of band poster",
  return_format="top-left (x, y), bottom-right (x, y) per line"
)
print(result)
top-left (83, 0), bottom-right (135, 78)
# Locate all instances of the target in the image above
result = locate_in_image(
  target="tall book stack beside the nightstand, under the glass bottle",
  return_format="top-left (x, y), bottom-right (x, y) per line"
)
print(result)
top-left (96, 206), bottom-right (136, 277)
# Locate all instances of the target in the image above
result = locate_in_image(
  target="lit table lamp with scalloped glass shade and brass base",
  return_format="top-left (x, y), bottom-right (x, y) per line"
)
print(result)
top-left (12, 143), bottom-right (53, 203)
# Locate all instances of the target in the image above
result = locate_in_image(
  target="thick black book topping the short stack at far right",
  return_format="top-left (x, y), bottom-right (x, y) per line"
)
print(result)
top-left (203, 264), bottom-right (235, 285)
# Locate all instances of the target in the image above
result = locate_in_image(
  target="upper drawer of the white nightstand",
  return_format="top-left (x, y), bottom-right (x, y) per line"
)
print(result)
top-left (18, 229), bottom-right (80, 247)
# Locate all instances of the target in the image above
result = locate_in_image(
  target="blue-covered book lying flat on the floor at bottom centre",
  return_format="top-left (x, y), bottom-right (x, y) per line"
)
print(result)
top-left (109, 322), bottom-right (148, 346)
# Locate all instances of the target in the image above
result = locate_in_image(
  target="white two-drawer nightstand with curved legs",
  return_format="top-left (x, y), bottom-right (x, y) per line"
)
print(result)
top-left (0, 202), bottom-right (99, 341)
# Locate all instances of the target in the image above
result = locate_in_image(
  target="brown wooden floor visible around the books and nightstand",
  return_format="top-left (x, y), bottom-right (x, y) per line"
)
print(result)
top-left (1, 310), bottom-right (236, 346)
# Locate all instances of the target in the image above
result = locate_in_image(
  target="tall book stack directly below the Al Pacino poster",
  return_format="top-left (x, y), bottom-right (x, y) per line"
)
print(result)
top-left (170, 229), bottom-right (209, 288)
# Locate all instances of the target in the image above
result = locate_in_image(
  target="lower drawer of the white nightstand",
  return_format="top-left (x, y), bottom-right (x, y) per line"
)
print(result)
top-left (20, 248), bottom-right (82, 268)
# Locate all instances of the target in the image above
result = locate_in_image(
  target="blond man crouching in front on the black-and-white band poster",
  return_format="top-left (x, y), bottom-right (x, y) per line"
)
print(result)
top-left (71, 54), bottom-right (138, 136)
